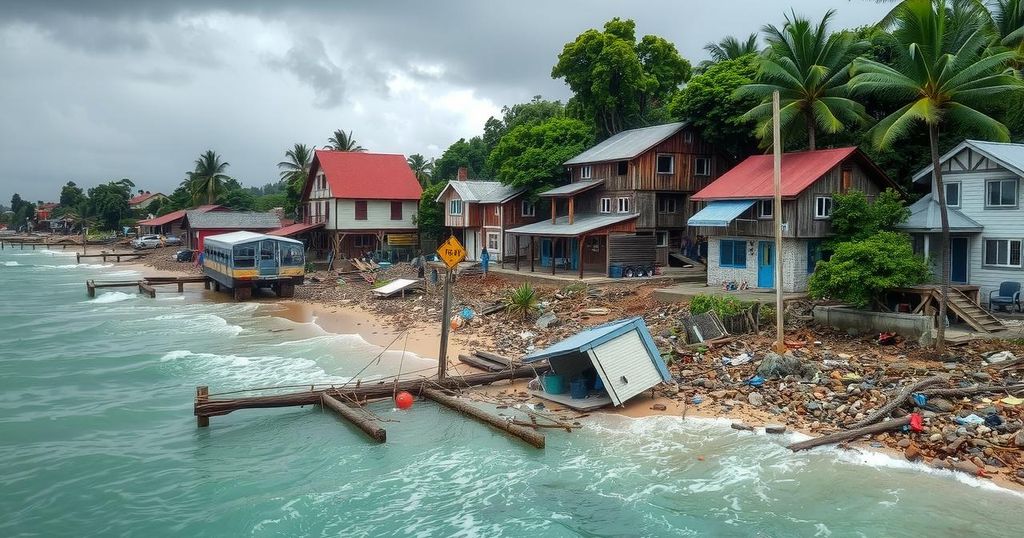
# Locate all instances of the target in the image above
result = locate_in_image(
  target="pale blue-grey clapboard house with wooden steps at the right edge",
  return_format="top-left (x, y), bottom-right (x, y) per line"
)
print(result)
top-left (899, 140), bottom-right (1024, 302)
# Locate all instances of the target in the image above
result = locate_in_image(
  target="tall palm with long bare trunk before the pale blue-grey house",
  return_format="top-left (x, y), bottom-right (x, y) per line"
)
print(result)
top-left (850, 0), bottom-right (1022, 353)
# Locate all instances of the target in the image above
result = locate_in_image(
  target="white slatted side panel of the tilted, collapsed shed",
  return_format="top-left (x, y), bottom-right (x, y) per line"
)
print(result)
top-left (591, 330), bottom-right (662, 406)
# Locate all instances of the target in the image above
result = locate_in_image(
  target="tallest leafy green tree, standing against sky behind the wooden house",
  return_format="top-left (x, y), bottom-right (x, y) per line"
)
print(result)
top-left (551, 17), bottom-right (691, 138)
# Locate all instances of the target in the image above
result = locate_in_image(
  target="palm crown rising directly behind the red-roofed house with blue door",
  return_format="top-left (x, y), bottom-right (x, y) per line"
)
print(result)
top-left (736, 10), bottom-right (867, 150)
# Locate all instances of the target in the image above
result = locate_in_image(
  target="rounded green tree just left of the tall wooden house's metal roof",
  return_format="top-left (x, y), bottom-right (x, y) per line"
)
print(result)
top-left (487, 118), bottom-right (594, 193)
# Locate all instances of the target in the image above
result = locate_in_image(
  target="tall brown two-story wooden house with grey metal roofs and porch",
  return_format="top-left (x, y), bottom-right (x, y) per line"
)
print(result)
top-left (512, 122), bottom-right (722, 275)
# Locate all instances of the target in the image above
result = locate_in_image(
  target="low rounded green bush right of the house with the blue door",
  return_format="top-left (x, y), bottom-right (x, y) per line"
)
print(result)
top-left (809, 232), bottom-right (931, 307)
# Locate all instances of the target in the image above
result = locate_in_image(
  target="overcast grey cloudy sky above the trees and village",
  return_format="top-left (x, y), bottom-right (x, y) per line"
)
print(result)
top-left (0, 0), bottom-right (891, 205)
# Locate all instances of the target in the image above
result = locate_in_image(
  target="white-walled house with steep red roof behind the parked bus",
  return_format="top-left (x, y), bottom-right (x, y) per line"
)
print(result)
top-left (299, 150), bottom-right (423, 258)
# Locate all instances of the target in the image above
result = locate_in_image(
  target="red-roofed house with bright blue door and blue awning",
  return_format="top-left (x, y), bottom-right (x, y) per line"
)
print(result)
top-left (687, 148), bottom-right (899, 292)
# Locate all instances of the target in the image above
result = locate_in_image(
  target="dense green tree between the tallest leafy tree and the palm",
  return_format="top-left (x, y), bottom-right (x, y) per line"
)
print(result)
top-left (669, 54), bottom-right (760, 161)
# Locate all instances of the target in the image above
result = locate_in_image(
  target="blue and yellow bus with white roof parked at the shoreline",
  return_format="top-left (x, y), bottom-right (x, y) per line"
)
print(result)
top-left (203, 232), bottom-right (306, 300)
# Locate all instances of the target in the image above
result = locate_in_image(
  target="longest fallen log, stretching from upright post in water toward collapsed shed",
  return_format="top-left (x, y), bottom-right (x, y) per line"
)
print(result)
top-left (193, 366), bottom-right (548, 417)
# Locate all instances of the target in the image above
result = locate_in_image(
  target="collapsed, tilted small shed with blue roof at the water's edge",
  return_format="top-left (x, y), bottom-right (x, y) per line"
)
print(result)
top-left (522, 318), bottom-right (672, 409)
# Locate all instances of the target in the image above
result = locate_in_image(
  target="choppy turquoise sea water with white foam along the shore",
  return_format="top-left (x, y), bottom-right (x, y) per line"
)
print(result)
top-left (0, 246), bottom-right (1024, 538)
